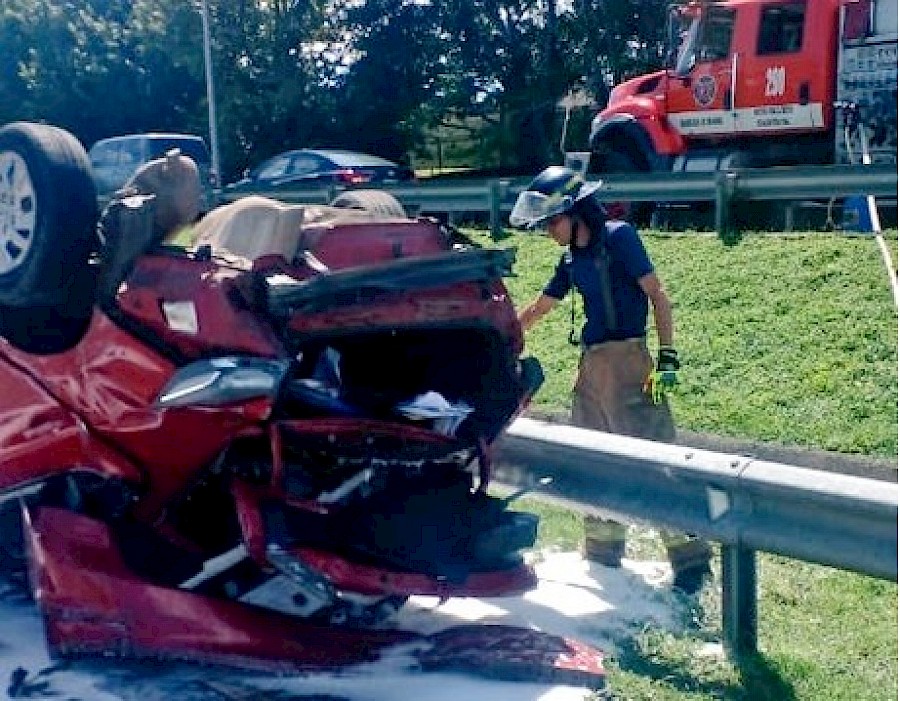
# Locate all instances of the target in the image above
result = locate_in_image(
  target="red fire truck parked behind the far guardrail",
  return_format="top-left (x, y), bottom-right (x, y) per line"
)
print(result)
top-left (590, 0), bottom-right (897, 173)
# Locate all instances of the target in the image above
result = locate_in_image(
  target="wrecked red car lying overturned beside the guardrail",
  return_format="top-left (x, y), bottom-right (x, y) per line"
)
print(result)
top-left (0, 122), bottom-right (603, 685)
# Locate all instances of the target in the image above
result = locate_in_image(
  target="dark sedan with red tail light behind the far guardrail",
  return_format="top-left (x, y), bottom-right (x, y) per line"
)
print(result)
top-left (225, 148), bottom-right (415, 193)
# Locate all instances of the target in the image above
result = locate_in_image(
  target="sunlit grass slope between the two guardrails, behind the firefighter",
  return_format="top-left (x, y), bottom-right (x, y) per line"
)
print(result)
top-left (472, 232), bottom-right (897, 457)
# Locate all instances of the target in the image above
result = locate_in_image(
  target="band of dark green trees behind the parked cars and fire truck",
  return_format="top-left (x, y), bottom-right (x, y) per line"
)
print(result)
top-left (0, 0), bottom-right (666, 180)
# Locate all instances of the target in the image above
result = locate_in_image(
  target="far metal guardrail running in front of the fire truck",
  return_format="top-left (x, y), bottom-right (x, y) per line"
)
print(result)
top-left (221, 164), bottom-right (898, 234)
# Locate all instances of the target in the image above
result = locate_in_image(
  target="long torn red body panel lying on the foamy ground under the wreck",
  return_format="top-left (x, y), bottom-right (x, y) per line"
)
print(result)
top-left (23, 508), bottom-right (419, 673)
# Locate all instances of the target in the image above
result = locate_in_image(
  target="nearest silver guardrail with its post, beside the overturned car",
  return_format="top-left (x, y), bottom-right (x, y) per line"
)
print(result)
top-left (494, 418), bottom-right (898, 655)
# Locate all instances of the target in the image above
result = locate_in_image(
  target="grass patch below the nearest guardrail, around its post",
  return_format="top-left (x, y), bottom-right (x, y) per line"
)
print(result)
top-left (517, 484), bottom-right (897, 701)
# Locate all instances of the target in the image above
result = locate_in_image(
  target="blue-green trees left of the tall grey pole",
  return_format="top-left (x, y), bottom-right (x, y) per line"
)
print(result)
top-left (0, 0), bottom-right (204, 145)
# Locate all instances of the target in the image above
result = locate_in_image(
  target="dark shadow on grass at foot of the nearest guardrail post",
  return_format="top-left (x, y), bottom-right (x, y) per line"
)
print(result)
top-left (614, 639), bottom-right (797, 701)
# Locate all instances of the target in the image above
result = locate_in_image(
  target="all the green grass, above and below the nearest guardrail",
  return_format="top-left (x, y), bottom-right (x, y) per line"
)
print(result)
top-left (474, 231), bottom-right (898, 701)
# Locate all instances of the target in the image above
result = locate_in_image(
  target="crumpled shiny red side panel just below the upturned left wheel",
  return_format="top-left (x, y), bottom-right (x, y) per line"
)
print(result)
top-left (0, 312), bottom-right (271, 519)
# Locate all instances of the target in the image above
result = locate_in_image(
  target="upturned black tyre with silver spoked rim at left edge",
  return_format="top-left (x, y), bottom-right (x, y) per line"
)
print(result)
top-left (0, 122), bottom-right (97, 308)
